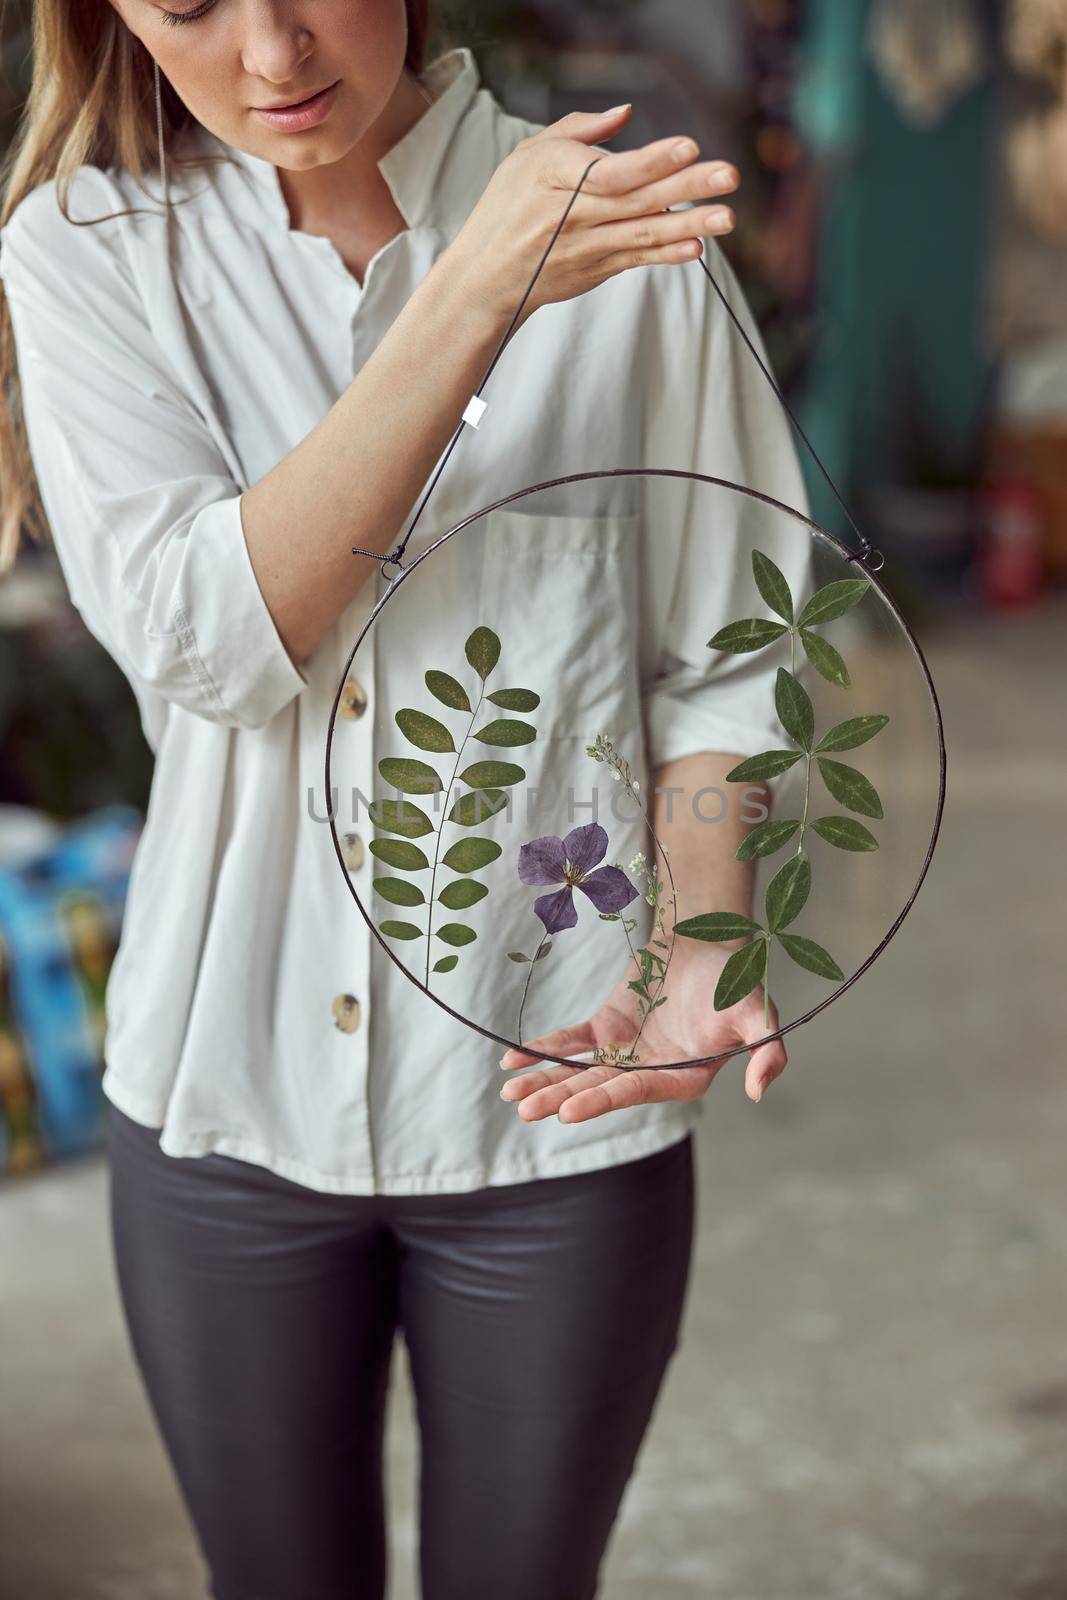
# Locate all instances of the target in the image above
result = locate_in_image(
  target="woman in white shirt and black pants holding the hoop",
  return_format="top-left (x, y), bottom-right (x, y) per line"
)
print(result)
top-left (0, 0), bottom-right (801, 1600)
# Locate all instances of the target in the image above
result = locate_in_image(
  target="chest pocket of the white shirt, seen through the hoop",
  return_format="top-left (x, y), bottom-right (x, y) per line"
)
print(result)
top-left (472, 506), bottom-right (643, 742)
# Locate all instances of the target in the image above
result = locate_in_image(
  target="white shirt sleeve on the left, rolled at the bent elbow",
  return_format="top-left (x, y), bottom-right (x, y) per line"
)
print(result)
top-left (0, 184), bottom-right (309, 728)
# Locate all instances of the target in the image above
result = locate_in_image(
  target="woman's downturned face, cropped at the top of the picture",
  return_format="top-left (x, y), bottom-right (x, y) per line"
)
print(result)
top-left (110, 0), bottom-right (408, 170)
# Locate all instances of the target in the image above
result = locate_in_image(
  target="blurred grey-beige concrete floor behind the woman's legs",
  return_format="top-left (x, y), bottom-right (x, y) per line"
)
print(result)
top-left (0, 595), bottom-right (1067, 1600)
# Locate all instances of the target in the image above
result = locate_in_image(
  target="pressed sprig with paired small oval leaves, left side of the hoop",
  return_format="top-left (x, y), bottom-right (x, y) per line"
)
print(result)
top-left (370, 627), bottom-right (541, 989)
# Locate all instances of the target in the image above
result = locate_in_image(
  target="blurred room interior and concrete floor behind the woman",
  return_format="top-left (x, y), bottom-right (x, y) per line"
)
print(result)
top-left (0, 0), bottom-right (1067, 1600)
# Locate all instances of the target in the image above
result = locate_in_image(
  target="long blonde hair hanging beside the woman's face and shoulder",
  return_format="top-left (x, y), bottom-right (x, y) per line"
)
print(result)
top-left (0, 0), bottom-right (429, 578)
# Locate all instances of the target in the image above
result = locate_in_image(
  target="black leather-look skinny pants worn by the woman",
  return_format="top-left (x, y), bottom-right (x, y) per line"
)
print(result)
top-left (109, 1107), bottom-right (694, 1600)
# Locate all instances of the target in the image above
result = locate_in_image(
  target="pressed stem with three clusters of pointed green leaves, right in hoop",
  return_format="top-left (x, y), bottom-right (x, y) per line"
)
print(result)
top-left (675, 550), bottom-right (889, 1027)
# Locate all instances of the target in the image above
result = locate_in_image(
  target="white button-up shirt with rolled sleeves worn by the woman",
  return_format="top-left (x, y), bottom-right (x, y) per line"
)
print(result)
top-left (0, 50), bottom-right (805, 1194)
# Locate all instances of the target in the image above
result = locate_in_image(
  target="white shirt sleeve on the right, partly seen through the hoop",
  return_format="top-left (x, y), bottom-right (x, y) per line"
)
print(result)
top-left (641, 230), bottom-right (813, 766)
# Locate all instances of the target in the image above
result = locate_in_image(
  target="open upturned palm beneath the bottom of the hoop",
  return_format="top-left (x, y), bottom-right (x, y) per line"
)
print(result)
top-left (501, 939), bottom-right (787, 1122)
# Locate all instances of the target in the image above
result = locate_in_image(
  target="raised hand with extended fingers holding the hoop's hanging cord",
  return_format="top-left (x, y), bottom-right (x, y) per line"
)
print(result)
top-left (445, 106), bottom-right (739, 323)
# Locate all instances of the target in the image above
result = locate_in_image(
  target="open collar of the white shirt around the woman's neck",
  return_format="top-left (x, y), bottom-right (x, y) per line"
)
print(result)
top-left (198, 45), bottom-right (491, 229)
